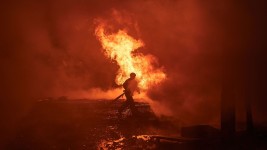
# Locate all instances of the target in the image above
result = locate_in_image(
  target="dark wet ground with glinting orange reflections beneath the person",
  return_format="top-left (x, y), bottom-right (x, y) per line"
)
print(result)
top-left (6, 98), bottom-right (267, 150)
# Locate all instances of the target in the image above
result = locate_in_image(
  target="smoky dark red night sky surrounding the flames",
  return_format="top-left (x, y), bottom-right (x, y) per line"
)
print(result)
top-left (0, 0), bottom-right (267, 145)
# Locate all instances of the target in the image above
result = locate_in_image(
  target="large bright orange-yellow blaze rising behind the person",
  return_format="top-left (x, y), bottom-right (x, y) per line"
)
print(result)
top-left (95, 23), bottom-right (166, 90)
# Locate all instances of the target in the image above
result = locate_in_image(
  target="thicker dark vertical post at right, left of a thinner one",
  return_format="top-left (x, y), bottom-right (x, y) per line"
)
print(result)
top-left (221, 38), bottom-right (238, 138)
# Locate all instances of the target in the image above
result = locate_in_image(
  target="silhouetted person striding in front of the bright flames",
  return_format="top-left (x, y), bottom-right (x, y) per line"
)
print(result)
top-left (118, 73), bottom-right (140, 118)
